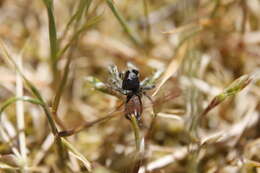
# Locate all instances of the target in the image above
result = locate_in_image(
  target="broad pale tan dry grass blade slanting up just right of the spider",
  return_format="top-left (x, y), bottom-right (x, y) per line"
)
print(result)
top-left (152, 43), bottom-right (187, 97)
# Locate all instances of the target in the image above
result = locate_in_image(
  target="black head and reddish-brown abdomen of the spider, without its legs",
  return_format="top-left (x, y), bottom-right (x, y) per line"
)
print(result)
top-left (122, 69), bottom-right (143, 121)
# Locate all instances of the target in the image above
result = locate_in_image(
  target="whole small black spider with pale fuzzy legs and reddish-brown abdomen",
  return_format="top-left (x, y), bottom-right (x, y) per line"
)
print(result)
top-left (109, 65), bottom-right (155, 122)
